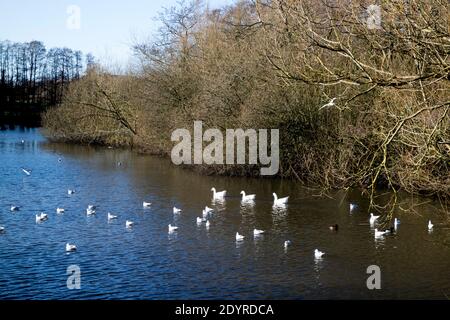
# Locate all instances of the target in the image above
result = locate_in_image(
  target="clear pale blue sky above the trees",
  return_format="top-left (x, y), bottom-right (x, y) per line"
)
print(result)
top-left (0, 0), bottom-right (233, 65)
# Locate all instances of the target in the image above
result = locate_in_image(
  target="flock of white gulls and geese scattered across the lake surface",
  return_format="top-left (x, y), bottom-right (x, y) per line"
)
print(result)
top-left (0, 154), bottom-right (434, 259)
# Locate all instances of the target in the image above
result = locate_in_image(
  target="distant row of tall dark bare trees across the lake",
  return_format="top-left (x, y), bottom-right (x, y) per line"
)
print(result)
top-left (0, 40), bottom-right (94, 120)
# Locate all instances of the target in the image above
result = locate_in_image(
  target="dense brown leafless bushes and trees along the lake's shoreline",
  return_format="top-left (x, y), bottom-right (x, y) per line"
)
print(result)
top-left (42, 0), bottom-right (450, 210)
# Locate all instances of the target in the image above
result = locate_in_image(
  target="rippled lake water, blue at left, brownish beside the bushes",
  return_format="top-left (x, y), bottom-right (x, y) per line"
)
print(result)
top-left (0, 125), bottom-right (450, 299)
